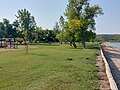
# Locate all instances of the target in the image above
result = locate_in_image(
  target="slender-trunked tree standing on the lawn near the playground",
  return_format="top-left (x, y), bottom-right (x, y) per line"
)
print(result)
top-left (16, 9), bottom-right (36, 53)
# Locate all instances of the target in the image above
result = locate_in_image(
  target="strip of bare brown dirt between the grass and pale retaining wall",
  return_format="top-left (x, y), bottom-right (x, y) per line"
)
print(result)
top-left (96, 55), bottom-right (111, 90)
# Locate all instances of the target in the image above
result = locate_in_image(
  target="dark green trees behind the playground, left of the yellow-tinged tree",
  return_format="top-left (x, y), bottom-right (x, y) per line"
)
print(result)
top-left (0, 9), bottom-right (58, 43)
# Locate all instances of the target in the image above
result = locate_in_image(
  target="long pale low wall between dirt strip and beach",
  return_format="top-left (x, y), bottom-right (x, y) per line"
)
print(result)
top-left (100, 46), bottom-right (118, 90)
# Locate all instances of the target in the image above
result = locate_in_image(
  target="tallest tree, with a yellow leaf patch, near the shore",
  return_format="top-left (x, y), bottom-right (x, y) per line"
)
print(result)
top-left (65, 0), bottom-right (103, 48)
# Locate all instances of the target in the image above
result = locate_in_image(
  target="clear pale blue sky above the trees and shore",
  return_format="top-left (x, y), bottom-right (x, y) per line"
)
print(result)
top-left (0, 0), bottom-right (120, 34)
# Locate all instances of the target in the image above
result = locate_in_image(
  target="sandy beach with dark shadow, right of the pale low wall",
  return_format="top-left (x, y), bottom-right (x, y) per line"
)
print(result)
top-left (103, 46), bottom-right (120, 90)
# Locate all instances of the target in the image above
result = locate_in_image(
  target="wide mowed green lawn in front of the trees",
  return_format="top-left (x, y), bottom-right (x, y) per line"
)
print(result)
top-left (0, 45), bottom-right (98, 90)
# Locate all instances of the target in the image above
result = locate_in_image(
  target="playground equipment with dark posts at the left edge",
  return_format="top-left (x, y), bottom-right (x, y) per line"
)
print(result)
top-left (0, 38), bottom-right (18, 49)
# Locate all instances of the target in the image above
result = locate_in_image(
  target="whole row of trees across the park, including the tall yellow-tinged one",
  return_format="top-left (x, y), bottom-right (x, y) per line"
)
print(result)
top-left (0, 0), bottom-right (103, 48)
